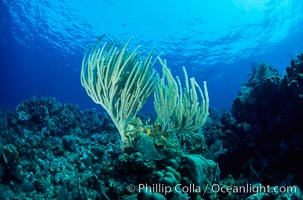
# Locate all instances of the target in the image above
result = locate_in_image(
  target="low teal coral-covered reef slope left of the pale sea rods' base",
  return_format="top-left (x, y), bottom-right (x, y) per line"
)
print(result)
top-left (0, 98), bottom-right (119, 199)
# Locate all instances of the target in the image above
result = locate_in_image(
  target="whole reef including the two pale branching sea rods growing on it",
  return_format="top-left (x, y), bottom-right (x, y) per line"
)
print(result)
top-left (0, 37), bottom-right (303, 200)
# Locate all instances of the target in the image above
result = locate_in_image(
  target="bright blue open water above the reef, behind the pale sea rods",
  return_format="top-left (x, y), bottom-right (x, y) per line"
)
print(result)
top-left (0, 0), bottom-right (303, 109)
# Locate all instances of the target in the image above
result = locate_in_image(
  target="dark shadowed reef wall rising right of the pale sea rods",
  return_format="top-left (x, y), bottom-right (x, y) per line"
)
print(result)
top-left (220, 54), bottom-right (303, 186)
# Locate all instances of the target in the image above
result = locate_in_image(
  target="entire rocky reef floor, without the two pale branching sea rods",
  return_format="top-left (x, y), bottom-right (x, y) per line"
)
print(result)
top-left (0, 54), bottom-right (303, 200)
